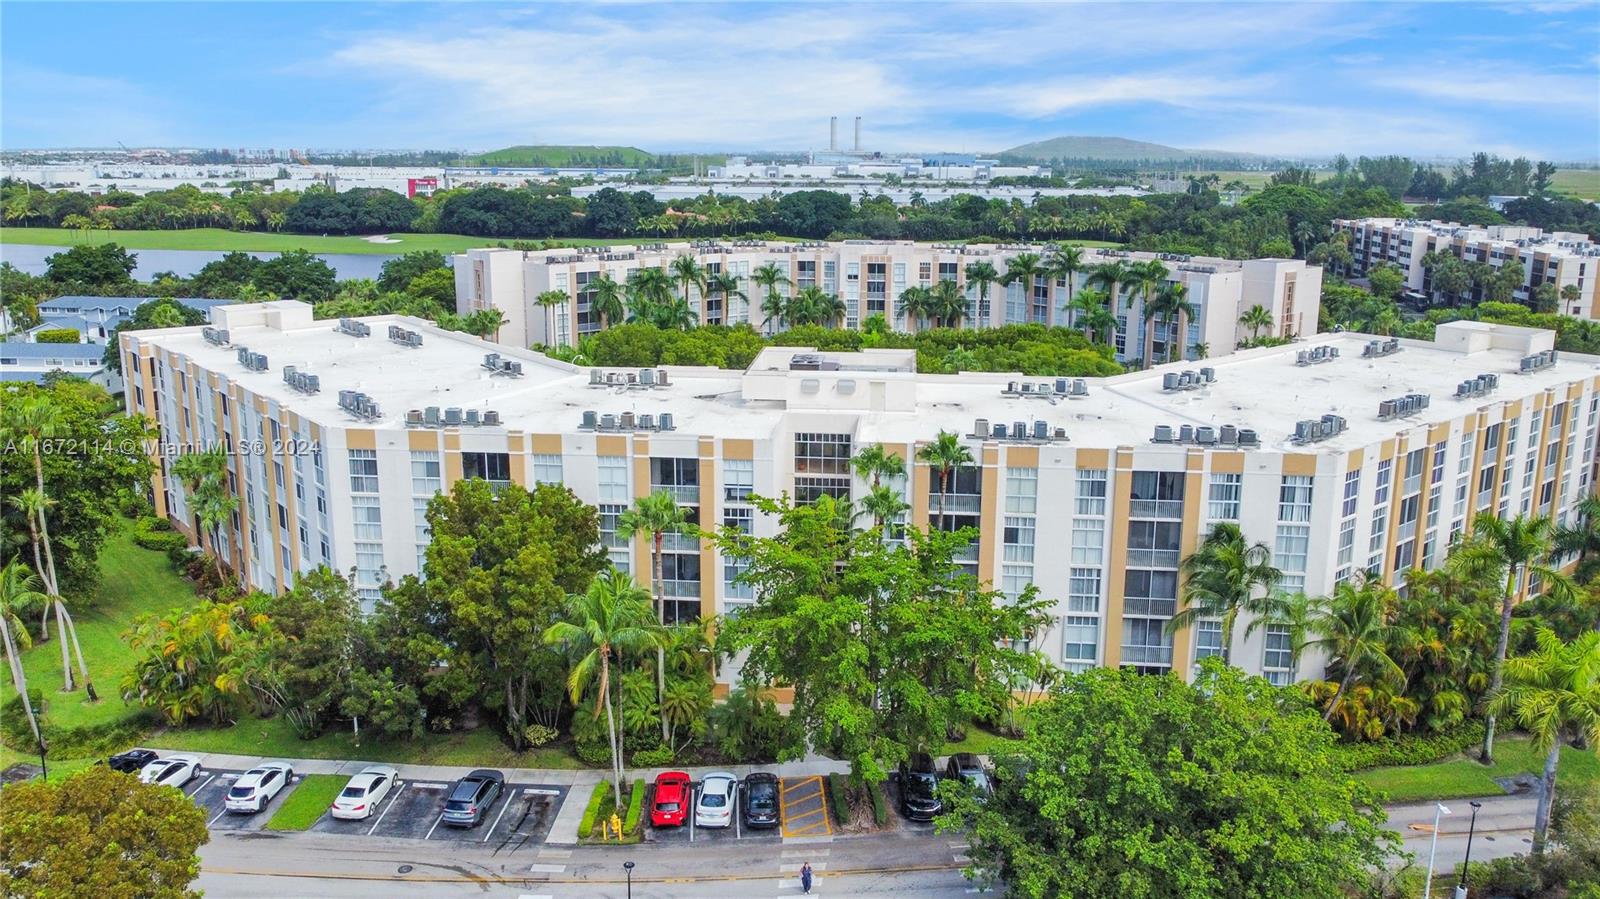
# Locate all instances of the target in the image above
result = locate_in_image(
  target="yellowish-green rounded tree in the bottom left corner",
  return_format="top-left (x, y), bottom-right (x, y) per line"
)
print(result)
top-left (0, 765), bottom-right (210, 899)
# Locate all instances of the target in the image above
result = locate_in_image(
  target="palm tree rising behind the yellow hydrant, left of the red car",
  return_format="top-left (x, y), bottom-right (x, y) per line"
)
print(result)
top-left (544, 568), bottom-right (666, 808)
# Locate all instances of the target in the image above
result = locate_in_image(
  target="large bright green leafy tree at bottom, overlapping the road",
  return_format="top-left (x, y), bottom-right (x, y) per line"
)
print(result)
top-left (941, 661), bottom-right (1400, 899)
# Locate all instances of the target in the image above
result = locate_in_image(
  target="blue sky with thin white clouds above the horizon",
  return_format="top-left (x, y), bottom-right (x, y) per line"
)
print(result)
top-left (0, 0), bottom-right (1600, 162)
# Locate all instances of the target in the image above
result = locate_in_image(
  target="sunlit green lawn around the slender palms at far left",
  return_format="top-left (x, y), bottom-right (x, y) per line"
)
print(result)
top-left (22, 520), bottom-right (195, 728)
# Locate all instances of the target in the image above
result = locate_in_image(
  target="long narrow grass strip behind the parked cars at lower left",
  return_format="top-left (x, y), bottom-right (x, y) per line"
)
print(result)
top-left (144, 717), bottom-right (584, 768)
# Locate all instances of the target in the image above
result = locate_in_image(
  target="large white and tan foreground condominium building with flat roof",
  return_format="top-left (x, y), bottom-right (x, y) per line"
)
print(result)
top-left (122, 301), bottom-right (1600, 683)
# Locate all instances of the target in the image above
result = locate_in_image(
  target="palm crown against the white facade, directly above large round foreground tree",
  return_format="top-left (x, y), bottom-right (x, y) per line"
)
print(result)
top-left (1166, 521), bottom-right (1283, 664)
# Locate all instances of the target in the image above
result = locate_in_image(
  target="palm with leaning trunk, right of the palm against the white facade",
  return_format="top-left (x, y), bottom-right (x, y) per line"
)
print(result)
top-left (1306, 577), bottom-right (1405, 721)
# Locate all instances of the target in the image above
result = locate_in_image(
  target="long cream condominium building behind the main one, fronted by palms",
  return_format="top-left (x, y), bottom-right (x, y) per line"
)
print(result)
top-left (454, 240), bottom-right (1322, 360)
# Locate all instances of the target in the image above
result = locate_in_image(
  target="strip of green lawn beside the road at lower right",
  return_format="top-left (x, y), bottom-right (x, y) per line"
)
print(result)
top-left (1355, 734), bottom-right (1600, 801)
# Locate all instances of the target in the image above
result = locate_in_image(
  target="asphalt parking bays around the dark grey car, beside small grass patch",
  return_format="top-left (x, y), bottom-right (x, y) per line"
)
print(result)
top-left (310, 771), bottom-right (566, 853)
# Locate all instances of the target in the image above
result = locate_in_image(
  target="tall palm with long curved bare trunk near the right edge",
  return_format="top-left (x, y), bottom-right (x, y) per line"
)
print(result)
top-left (1450, 512), bottom-right (1573, 765)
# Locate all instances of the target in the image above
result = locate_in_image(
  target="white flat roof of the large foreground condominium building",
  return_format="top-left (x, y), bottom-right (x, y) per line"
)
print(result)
top-left (138, 303), bottom-right (1600, 453)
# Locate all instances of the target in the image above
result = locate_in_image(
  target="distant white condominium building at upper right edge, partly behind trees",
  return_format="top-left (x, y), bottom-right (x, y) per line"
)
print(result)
top-left (1333, 219), bottom-right (1600, 318)
